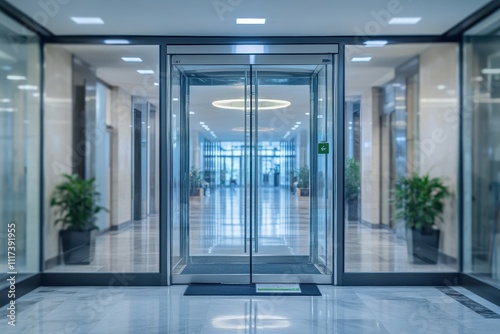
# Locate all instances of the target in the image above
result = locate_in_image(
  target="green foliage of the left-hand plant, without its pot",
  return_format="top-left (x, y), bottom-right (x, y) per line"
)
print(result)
top-left (50, 174), bottom-right (107, 231)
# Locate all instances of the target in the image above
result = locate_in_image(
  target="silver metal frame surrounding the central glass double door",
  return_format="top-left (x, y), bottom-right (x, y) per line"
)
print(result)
top-left (166, 44), bottom-right (338, 284)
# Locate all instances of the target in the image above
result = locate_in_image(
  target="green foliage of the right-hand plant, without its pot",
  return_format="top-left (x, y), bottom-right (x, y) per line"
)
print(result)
top-left (393, 173), bottom-right (450, 230)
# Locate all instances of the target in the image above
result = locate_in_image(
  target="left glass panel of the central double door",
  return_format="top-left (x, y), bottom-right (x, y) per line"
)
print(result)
top-left (171, 65), bottom-right (250, 283)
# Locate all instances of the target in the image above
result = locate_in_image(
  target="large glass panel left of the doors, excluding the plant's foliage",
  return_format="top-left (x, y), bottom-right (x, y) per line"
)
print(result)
top-left (43, 44), bottom-right (159, 273)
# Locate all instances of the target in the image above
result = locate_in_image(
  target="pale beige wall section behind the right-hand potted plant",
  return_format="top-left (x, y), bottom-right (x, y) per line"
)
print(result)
top-left (419, 44), bottom-right (459, 258)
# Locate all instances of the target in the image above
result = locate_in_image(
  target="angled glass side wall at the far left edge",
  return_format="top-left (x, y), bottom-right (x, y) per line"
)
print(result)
top-left (0, 13), bottom-right (41, 288)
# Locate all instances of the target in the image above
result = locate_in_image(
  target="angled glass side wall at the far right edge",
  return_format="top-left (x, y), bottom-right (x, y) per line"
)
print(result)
top-left (463, 11), bottom-right (500, 287)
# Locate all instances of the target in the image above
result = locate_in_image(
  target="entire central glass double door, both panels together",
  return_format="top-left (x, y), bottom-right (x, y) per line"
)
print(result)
top-left (169, 55), bottom-right (333, 283)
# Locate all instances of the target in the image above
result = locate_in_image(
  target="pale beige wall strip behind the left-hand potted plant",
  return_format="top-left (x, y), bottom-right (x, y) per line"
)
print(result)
top-left (43, 45), bottom-right (73, 260)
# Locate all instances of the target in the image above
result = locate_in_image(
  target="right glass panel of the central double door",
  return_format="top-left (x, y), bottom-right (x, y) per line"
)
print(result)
top-left (252, 64), bottom-right (333, 283)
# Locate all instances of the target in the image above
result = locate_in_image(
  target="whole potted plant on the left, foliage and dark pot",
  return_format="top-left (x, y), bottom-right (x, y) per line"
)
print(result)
top-left (50, 174), bottom-right (106, 264)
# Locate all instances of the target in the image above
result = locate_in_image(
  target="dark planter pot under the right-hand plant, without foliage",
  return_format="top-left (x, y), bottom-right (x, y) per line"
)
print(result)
top-left (407, 228), bottom-right (440, 264)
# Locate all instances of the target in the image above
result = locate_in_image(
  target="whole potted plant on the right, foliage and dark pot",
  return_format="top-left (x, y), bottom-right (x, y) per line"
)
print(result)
top-left (393, 173), bottom-right (450, 264)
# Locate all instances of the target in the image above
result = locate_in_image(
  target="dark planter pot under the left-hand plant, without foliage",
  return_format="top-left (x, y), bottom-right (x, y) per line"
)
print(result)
top-left (59, 229), bottom-right (96, 264)
